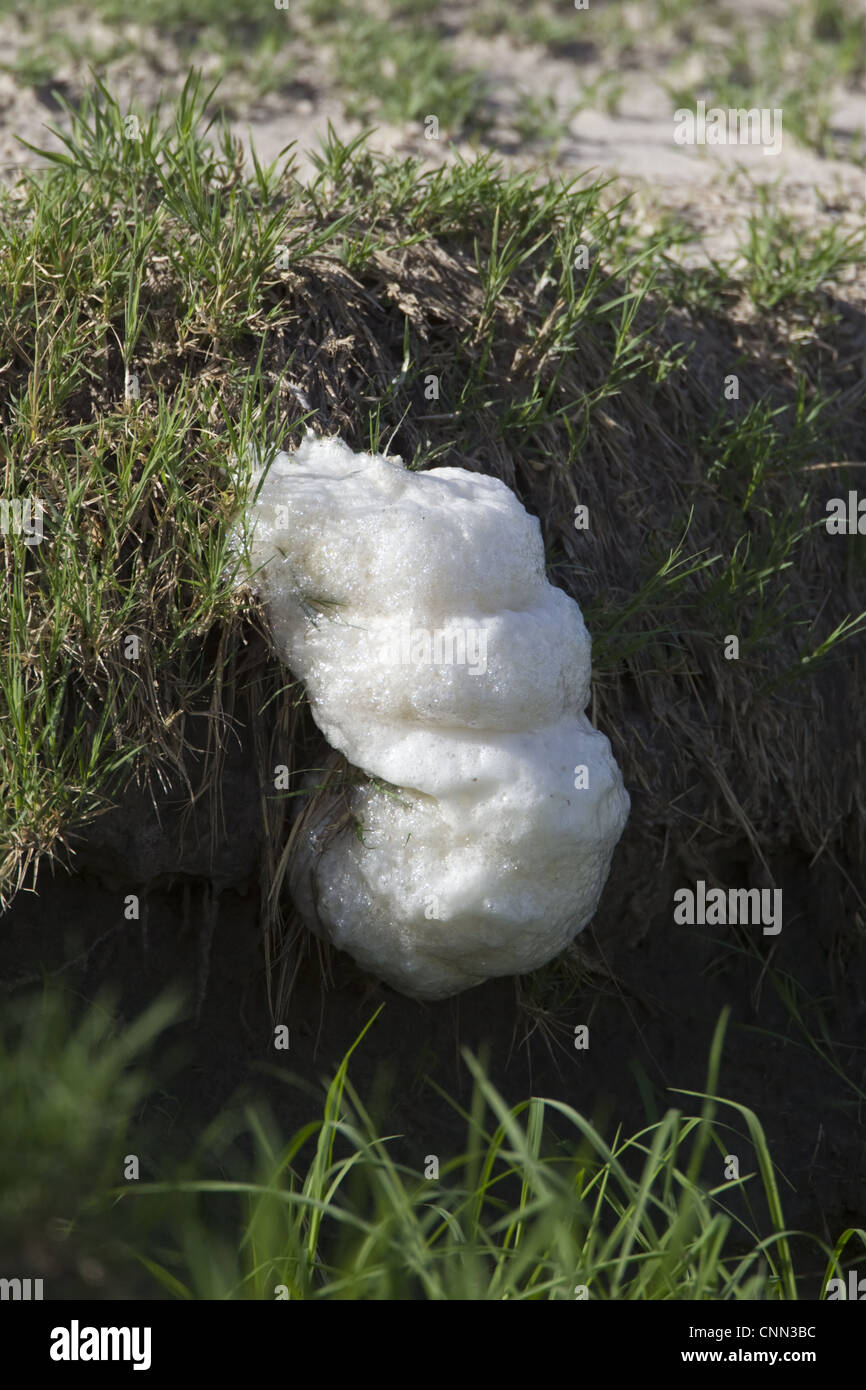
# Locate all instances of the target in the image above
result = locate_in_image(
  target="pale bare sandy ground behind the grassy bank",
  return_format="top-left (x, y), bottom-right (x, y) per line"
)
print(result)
top-left (0, 4), bottom-right (866, 268)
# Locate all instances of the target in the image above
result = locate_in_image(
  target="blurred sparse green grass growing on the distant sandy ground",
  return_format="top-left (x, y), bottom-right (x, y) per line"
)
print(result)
top-left (0, 0), bottom-right (866, 160)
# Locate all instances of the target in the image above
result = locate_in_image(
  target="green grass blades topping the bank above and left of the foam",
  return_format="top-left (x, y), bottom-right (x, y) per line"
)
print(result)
top-left (0, 70), bottom-right (863, 917)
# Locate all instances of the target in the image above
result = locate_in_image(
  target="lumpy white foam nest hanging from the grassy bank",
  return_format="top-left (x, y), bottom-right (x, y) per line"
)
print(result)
top-left (237, 436), bottom-right (630, 999)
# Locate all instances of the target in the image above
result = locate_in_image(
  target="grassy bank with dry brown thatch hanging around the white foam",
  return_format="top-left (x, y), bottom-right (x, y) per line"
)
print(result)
top-left (0, 79), bottom-right (863, 1011)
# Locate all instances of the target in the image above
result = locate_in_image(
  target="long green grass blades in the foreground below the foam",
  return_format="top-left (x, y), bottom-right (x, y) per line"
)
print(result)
top-left (0, 991), bottom-right (866, 1301)
